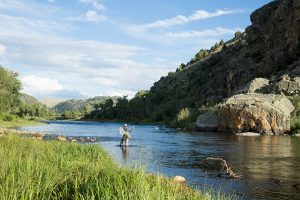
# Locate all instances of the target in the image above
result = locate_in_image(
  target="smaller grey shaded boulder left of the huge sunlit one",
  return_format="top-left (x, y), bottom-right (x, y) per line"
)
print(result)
top-left (196, 112), bottom-right (218, 132)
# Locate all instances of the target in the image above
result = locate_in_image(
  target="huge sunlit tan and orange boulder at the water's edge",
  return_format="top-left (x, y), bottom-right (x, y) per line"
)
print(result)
top-left (218, 94), bottom-right (294, 135)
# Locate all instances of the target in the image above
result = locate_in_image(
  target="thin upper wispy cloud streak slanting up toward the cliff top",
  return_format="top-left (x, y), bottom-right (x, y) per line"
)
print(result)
top-left (139, 9), bottom-right (242, 31)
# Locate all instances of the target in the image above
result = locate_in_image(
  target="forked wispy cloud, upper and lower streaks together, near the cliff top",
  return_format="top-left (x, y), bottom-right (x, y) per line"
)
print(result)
top-left (123, 9), bottom-right (244, 44)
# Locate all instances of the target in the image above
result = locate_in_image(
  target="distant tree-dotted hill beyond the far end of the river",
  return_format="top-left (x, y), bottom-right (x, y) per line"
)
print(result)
top-left (52, 96), bottom-right (119, 114)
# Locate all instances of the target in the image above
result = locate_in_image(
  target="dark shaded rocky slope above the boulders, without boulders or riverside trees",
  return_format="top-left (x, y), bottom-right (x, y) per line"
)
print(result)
top-left (147, 0), bottom-right (300, 120)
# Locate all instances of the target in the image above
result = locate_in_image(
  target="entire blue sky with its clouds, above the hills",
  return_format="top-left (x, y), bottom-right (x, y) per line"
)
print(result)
top-left (0, 0), bottom-right (270, 99)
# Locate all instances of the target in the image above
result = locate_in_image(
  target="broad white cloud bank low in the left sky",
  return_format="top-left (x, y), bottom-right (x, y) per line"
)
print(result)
top-left (0, 10), bottom-right (162, 97)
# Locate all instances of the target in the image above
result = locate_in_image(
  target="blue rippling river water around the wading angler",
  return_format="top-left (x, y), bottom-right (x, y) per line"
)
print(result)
top-left (19, 121), bottom-right (300, 199)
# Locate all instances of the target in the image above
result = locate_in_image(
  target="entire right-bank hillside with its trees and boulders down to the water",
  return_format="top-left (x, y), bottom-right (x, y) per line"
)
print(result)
top-left (87, 0), bottom-right (300, 134)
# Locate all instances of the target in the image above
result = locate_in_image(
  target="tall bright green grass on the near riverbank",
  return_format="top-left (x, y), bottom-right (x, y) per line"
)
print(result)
top-left (0, 135), bottom-right (227, 200)
